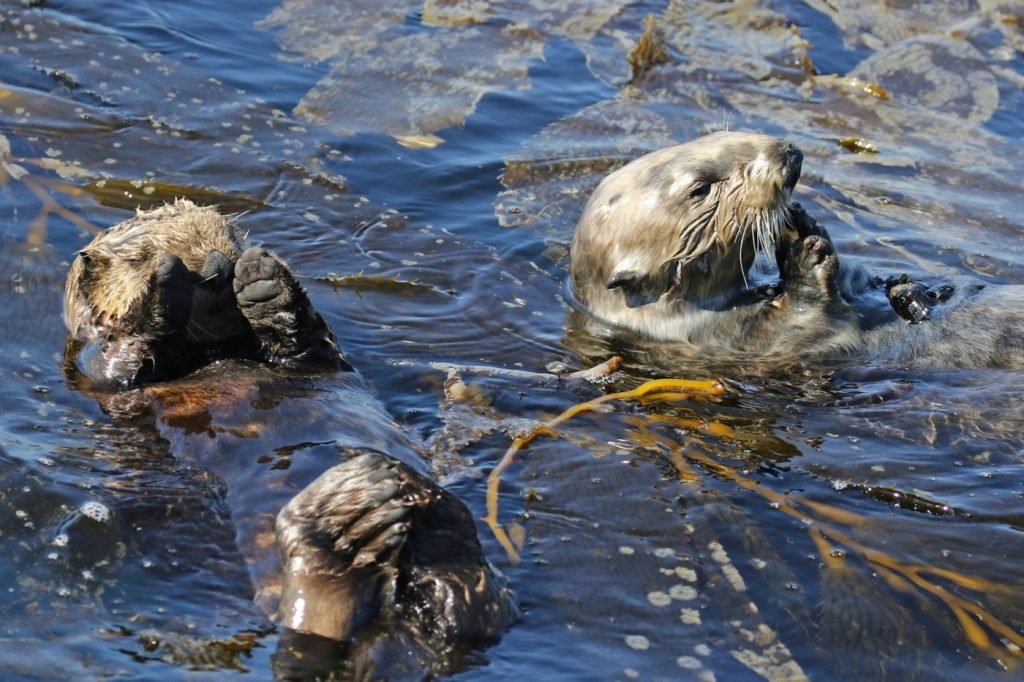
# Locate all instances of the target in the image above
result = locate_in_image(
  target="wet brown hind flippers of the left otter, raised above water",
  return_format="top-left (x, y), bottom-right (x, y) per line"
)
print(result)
top-left (276, 451), bottom-right (518, 643)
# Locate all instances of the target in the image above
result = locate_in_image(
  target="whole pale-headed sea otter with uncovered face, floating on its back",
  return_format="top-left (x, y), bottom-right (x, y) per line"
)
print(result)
top-left (569, 132), bottom-right (1024, 368)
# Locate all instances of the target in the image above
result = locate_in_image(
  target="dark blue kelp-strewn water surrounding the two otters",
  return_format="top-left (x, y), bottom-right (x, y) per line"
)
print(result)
top-left (0, 0), bottom-right (1024, 680)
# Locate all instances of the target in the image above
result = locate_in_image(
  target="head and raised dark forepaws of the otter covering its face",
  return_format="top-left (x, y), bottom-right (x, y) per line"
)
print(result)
top-left (65, 200), bottom-right (345, 387)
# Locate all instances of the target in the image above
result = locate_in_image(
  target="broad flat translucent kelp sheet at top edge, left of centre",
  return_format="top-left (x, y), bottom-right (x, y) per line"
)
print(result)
top-left (261, 0), bottom-right (627, 147)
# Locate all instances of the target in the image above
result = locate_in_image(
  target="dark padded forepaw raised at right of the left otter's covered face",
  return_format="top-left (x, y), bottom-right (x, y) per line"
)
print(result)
top-left (233, 247), bottom-right (349, 369)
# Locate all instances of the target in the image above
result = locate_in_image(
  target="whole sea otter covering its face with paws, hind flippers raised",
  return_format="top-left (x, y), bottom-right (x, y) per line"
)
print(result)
top-left (65, 200), bottom-right (517, 657)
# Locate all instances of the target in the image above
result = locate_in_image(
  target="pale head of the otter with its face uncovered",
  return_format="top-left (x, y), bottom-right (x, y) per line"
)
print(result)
top-left (570, 132), bottom-right (803, 343)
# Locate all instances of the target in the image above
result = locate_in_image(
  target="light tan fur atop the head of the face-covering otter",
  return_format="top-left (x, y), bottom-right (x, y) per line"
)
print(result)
top-left (63, 199), bottom-right (239, 342)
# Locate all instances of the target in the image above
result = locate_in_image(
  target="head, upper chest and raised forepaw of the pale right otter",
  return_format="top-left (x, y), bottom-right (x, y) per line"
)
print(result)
top-left (569, 132), bottom-right (857, 353)
